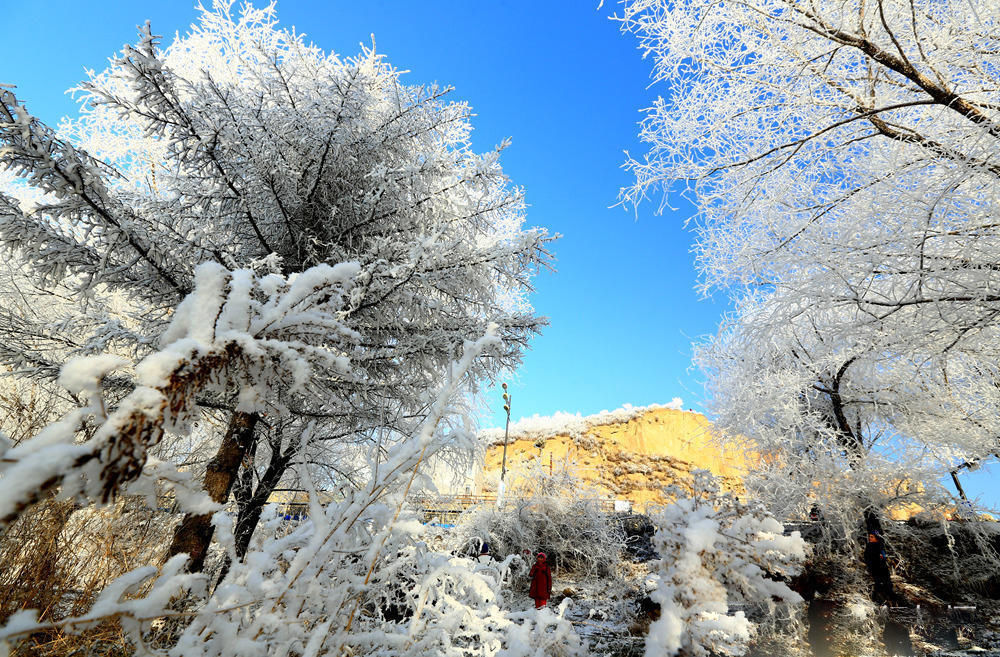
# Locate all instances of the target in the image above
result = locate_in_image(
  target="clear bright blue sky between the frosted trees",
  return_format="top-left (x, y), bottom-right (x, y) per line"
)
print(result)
top-left (0, 0), bottom-right (1000, 500)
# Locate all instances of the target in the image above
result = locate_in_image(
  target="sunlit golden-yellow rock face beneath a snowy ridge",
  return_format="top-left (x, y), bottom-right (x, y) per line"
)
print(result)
top-left (478, 407), bottom-right (759, 510)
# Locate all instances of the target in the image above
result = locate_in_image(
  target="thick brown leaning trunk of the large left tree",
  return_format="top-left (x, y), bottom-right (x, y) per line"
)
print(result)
top-left (164, 411), bottom-right (260, 572)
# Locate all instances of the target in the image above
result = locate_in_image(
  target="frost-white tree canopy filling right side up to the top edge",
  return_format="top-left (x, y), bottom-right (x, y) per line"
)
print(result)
top-left (620, 0), bottom-right (1000, 519)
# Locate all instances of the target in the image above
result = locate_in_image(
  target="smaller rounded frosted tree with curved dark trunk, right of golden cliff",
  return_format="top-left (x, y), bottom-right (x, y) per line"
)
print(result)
top-left (695, 294), bottom-right (960, 535)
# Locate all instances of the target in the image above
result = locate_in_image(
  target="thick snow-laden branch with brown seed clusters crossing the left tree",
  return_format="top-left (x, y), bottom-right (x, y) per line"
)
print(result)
top-left (0, 264), bottom-right (358, 527)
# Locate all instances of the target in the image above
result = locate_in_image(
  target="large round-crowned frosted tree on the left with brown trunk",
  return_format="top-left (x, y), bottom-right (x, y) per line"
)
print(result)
top-left (0, 2), bottom-right (548, 565)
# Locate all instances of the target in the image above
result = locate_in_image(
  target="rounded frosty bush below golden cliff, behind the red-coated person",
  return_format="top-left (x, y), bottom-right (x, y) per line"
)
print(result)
top-left (454, 467), bottom-right (625, 577)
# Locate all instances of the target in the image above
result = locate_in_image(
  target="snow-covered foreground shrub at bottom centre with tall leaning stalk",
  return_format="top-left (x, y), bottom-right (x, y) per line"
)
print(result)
top-left (153, 476), bottom-right (581, 657)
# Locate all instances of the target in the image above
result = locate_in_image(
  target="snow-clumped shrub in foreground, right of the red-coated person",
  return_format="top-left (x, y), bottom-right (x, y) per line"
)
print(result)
top-left (646, 471), bottom-right (806, 657)
